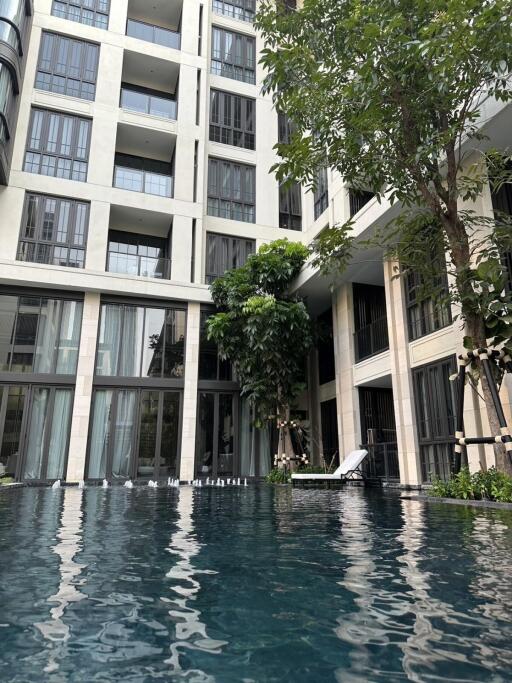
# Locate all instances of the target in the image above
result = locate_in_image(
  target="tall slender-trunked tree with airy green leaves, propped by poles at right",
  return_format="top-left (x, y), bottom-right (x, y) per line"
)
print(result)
top-left (256, 0), bottom-right (512, 470)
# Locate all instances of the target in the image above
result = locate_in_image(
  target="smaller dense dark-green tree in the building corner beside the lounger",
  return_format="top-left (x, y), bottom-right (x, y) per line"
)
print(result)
top-left (207, 240), bottom-right (312, 464)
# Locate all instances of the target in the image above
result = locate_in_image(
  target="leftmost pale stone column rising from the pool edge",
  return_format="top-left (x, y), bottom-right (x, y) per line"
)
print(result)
top-left (66, 292), bottom-right (100, 482)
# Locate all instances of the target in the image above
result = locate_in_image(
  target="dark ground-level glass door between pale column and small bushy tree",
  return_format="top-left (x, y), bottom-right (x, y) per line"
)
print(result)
top-left (196, 391), bottom-right (239, 478)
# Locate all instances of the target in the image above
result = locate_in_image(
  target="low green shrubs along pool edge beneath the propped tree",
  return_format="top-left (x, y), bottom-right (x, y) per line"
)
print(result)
top-left (430, 467), bottom-right (512, 503)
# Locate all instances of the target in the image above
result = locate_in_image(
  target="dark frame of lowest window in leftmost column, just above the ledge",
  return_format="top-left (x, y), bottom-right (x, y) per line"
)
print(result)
top-left (16, 191), bottom-right (90, 268)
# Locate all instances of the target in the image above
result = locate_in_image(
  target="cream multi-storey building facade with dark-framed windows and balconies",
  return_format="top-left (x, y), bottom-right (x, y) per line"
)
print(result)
top-left (0, 0), bottom-right (510, 492)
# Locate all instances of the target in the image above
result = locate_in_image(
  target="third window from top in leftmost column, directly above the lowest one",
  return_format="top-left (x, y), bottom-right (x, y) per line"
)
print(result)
top-left (23, 109), bottom-right (91, 182)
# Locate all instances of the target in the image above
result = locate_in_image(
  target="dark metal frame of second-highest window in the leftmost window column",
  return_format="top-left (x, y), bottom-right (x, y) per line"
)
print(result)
top-left (34, 31), bottom-right (100, 102)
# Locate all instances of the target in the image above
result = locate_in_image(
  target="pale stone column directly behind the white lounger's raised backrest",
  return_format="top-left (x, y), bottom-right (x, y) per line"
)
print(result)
top-left (332, 284), bottom-right (361, 462)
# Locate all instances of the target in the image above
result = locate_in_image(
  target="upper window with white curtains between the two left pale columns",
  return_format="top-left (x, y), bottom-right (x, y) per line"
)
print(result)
top-left (96, 303), bottom-right (186, 379)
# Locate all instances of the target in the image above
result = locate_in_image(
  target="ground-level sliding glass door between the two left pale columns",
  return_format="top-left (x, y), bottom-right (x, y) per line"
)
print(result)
top-left (87, 389), bottom-right (181, 479)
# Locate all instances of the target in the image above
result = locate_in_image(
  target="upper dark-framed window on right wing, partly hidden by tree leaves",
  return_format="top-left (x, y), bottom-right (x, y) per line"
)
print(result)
top-left (404, 259), bottom-right (452, 341)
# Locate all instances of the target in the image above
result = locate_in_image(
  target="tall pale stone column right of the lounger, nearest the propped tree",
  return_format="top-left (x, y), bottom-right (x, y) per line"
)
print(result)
top-left (384, 261), bottom-right (421, 486)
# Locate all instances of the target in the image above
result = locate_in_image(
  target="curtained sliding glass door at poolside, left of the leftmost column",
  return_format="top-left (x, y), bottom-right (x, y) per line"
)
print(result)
top-left (0, 384), bottom-right (73, 481)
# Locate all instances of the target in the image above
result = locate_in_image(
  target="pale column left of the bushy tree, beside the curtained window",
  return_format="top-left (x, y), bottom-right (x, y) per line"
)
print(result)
top-left (180, 303), bottom-right (201, 479)
